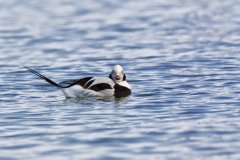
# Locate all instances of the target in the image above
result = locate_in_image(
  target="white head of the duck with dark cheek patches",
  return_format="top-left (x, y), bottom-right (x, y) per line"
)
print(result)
top-left (109, 65), bottom-right (126, 83)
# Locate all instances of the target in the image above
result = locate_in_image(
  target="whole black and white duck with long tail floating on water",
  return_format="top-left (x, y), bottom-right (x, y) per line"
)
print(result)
top-left (24, 65), bottom-right (131, 98)
